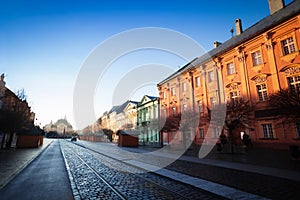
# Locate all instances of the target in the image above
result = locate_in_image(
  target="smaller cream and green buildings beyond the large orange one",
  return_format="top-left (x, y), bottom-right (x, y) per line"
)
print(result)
top-left (88, 95), bottom-right (161, 146)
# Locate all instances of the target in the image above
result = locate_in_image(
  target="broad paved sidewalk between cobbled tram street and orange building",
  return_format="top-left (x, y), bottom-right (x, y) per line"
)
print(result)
top-left (77, 141), bottom-right (300, 199)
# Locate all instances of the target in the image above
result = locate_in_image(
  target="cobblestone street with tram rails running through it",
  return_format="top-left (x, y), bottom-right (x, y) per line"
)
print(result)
top-left (61, 140), bottom-right (222, 199)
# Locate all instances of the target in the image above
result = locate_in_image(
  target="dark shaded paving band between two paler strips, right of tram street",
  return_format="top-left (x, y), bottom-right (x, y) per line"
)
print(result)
top-left (74, 141), bottom-right (300, 199)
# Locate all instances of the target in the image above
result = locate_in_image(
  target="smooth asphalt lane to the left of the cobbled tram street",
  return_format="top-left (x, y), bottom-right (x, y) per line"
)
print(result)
top-left (0, 141), bottom-right (74, 200)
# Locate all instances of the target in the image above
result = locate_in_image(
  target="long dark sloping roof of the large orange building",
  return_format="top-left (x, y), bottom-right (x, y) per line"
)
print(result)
top-left (157, 0), bottom-right (300, 86)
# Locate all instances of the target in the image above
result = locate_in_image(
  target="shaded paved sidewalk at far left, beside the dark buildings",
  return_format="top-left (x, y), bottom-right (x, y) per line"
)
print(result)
top-left (0, 138), bottom-right (53, 190)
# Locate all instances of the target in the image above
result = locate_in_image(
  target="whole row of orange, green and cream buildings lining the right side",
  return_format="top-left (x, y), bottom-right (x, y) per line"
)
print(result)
top-left (84, 0), bottom-right (300, 148)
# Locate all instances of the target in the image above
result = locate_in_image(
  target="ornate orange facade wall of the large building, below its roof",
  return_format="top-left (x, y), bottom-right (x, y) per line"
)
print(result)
top-left (158, 8), bottom-right (300, 146)
